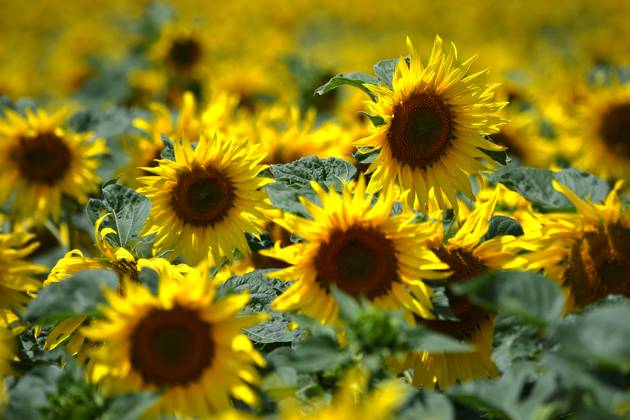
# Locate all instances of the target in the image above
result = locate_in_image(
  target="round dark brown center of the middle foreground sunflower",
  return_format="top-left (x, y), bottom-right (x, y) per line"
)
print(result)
top-left (315, 226), bottom-right (398, 299)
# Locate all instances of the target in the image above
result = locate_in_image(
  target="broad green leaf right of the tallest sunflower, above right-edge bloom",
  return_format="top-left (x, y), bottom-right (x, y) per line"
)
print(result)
top-left (488, 164), bottom-right (610, 211)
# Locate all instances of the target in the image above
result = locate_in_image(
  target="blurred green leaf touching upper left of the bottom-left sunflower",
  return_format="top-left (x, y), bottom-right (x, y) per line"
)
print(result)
top-left (26, 270), bottom-right (118, 324)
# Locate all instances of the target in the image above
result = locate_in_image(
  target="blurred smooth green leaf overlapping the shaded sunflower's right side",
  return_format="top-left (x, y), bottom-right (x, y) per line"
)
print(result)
top-left (452, 271), bottom-right (564, 328)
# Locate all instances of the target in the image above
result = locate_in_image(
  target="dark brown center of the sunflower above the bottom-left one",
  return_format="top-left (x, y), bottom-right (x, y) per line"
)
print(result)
top-left (171, 167), bottom-right (235, 226)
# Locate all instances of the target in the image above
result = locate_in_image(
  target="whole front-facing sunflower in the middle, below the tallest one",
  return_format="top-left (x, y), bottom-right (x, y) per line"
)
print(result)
top-left (261, 177), bottom-right (448, 323)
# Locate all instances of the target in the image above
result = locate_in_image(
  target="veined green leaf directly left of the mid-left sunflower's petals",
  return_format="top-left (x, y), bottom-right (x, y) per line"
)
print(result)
top-left (86, 184), bottom-right (151, 248)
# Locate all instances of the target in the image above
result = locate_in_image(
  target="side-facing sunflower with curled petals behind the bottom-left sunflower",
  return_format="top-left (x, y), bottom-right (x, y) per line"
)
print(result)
top-left (44, 217), bottom-right (190, 360)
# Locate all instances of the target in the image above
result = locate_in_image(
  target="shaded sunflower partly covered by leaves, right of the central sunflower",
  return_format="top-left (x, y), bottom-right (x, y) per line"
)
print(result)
top-left (403, 195), bottom-right (518, 389)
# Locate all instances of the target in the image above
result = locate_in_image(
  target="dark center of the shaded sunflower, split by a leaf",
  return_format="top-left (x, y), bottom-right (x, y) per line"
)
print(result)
top-left (416, 247), bottom-right (492, 340)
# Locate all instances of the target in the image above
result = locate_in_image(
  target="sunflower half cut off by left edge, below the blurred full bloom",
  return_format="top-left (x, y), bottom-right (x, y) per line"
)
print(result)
top-left (0, 232), bottom-right (48, 324)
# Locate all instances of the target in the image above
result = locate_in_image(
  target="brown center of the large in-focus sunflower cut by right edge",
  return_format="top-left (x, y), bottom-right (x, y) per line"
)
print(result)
top-left (565, 224), bottom-right (630, 307)
